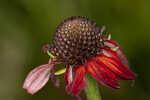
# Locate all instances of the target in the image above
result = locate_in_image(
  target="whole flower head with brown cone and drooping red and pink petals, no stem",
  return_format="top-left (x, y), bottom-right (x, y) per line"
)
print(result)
top-left (23, 17), bottom-right (136, 99)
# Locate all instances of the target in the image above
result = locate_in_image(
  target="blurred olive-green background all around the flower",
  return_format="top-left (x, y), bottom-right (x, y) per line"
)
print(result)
top-left (0, 0), bottom-right (150, 100)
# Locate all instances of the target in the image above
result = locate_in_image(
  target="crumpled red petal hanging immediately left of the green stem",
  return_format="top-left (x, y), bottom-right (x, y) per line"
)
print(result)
top-left (67, 66), bottom-right (86, 97)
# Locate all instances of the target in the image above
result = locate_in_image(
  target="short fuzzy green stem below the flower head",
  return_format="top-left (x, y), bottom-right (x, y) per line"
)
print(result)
top-left (85, 75), bottom-right (102, 100)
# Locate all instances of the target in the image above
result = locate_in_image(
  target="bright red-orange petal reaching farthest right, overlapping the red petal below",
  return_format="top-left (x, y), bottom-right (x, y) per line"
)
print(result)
top-left (97, 55), bottom-right (136, 80)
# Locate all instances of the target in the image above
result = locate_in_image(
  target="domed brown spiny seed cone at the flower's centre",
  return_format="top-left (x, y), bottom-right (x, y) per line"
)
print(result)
top-left (50, 17), bottom-right (102, 65)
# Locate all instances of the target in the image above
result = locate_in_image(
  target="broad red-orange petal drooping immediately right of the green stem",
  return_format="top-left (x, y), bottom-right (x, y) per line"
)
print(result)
top-left (86, 59), bottom-right (119, 89)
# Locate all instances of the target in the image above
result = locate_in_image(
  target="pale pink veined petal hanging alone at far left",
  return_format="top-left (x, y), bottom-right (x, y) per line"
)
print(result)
top-left (23, 64), bottom-right (54, 94)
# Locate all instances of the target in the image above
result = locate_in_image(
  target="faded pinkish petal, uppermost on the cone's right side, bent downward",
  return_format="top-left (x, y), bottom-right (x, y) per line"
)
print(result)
top-left (104, 40), bottom-right (129, 67)
